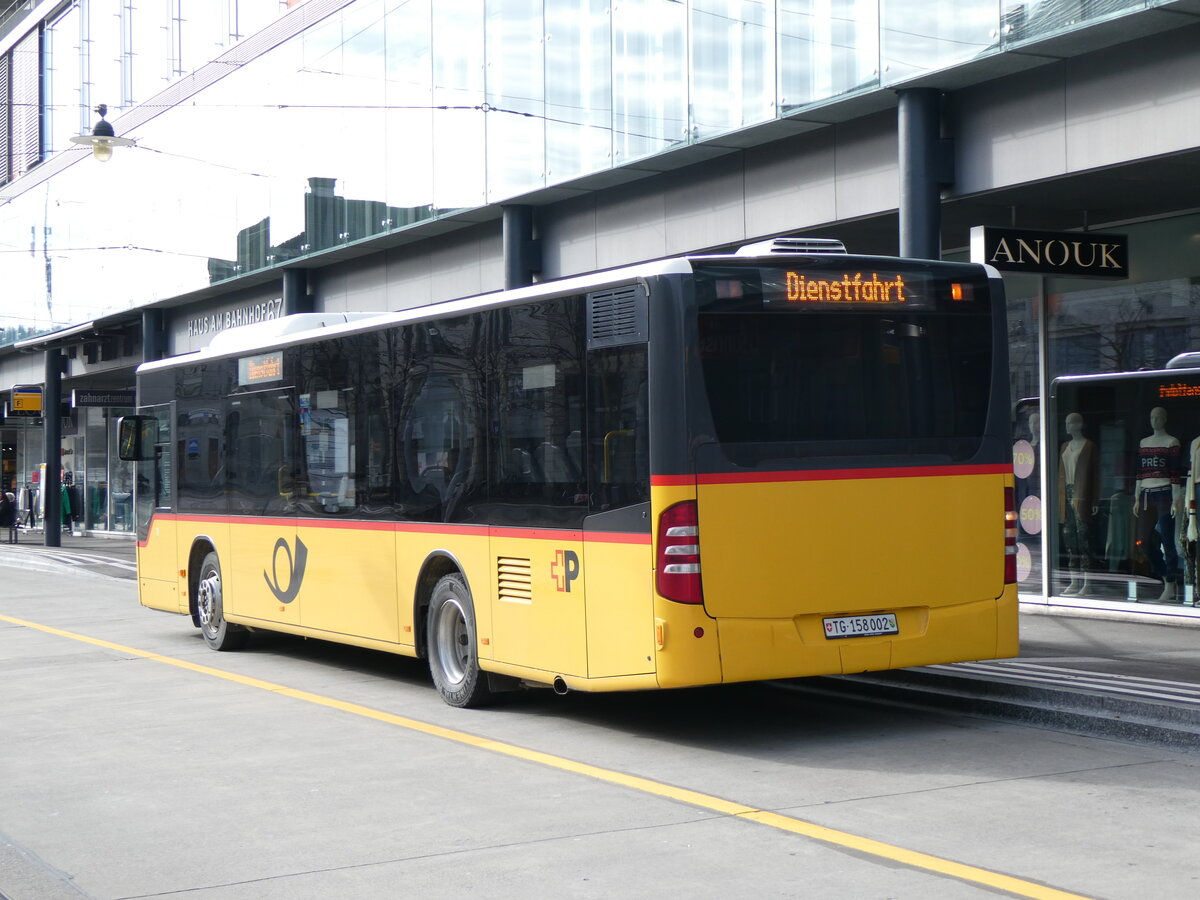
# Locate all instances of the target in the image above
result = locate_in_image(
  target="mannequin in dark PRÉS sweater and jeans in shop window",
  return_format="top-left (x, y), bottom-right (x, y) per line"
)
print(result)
top-left (1133, 407), bottom-right (1183, 604)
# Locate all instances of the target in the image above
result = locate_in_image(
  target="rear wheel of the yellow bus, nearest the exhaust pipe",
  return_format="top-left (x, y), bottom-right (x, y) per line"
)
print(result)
top-left (426, 572), bottom-right (492, 709)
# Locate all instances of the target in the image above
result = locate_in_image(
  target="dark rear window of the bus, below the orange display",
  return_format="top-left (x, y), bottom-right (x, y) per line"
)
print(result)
top-left (697, 264), bottom-right (992, 468)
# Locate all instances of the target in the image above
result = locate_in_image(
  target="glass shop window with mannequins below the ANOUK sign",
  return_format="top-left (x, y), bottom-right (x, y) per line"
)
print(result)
top-left (1004, 215), bottom-right (1200, 606)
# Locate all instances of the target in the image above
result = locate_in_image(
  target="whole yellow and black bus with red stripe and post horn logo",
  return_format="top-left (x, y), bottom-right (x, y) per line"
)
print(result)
top-left (120, 240), bottom-right (1016, 707)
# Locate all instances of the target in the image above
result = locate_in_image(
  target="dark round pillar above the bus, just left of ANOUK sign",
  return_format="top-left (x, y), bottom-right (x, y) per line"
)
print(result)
top-left (896, 88), bottom-right (954, 259)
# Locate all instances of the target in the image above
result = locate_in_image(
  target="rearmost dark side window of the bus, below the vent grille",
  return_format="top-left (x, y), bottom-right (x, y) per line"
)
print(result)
top-left (587, 344), bottom-right (650, 512)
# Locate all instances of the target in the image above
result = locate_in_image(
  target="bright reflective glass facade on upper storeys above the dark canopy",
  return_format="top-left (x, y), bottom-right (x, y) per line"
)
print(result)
top-left (0, 0), bottom-right (1158, 343)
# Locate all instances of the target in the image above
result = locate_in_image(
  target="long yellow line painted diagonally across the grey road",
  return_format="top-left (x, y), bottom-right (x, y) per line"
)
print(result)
top-left (0, 614), bottom-right (1087, 900)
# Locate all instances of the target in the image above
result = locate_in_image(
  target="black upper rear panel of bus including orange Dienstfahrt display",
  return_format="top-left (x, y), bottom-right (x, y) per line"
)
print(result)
top-left (696, 257), bottom-right (992, 468)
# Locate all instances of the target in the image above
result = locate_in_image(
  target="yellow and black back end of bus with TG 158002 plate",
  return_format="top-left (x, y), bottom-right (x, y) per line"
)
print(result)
top-left (652, 253), bottom-right (1016, 686)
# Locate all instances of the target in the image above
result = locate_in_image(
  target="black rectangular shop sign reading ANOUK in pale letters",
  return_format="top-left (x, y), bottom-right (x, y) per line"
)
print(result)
top-left (971, 226), bottom-right (1129, 278)
